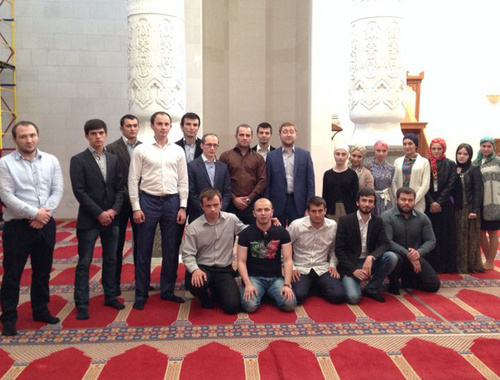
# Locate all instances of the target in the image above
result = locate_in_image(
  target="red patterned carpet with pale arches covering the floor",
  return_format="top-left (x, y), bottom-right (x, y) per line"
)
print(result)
top-left (0, 222), bottom-right (500, 380)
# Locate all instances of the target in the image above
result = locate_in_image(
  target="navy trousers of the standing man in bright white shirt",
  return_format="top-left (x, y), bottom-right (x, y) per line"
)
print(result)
top-left (135, 193), bottom-right (180, 301)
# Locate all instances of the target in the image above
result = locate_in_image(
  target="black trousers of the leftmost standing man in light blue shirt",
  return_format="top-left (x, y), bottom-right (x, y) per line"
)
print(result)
top-left (0, 218), bottom-right (56, 326)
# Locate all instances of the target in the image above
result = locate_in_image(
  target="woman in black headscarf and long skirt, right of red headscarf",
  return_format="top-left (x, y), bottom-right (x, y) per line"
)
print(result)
top-left (454, 143), bottom-right (484, 273)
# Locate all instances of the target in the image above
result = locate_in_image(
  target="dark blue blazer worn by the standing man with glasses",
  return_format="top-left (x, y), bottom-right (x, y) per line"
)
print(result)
top-left (188, 157), bottom-right (231, 223)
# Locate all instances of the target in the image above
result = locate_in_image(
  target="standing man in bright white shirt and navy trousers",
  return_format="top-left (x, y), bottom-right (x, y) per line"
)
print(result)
top-left (128, 112), bottom-right (189, 310)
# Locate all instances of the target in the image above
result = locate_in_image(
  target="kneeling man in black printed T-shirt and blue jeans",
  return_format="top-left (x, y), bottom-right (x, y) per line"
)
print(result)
top-left (238, 198), bottom-right (297, 313)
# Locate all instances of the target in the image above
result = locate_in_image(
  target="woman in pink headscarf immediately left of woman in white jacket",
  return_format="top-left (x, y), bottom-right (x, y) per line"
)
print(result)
top-left (366, 140), bottom-right (394, 216)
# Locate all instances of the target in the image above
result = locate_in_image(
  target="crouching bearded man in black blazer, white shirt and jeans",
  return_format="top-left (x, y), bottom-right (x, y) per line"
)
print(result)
top-left (335, 187), bottom-right (398, 305)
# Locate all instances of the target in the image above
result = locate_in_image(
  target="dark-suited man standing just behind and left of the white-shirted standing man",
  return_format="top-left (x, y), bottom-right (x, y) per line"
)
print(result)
top-left (106, 115), bottom-right (142, 295)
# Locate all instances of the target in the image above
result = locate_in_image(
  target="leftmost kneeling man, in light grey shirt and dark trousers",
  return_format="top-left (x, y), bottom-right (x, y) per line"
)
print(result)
top-left (182, 188), bottom-right (247, 314)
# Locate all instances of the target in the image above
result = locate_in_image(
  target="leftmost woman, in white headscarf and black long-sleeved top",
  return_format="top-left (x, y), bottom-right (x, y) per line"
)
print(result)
top-left (323, 144), bottom-right (359, 222)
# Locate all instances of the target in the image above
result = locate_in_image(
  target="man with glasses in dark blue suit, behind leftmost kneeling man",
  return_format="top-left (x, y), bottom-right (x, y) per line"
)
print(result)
top-left (188, 133), bottom-right (231, 223)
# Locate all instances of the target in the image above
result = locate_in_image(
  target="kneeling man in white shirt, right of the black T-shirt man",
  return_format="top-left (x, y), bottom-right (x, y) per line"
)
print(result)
top-left (288, 196), bottom-right (345, 305)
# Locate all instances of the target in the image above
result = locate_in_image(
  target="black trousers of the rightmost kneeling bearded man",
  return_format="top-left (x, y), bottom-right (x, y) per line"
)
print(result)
top-left (389, 254), bottom-right (441, 293)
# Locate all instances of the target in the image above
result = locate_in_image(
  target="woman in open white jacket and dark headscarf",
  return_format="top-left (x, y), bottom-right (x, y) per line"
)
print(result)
top-left (392, 133), bottom-right (431, 212)
